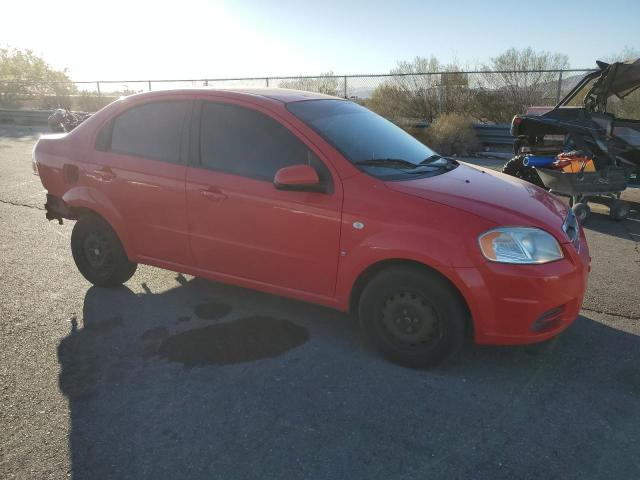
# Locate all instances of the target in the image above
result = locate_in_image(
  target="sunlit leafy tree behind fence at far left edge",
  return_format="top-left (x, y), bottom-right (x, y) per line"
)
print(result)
top-left (0, 47), bottom-right (77, 106)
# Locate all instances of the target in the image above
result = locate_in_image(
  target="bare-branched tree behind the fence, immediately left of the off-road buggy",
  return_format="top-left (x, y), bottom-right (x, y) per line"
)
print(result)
top-left (478, 47), bottom-right (569, 121)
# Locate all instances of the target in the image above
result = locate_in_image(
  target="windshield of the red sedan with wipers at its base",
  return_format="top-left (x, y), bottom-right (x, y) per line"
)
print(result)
top-left (287, 100), bottom-right (450, 177)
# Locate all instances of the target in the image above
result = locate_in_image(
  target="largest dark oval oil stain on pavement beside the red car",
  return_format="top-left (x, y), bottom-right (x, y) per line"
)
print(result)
top-left (155, 315), bottom-right (309, 367)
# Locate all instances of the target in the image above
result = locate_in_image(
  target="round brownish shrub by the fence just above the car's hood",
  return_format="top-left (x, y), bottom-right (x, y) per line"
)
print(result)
top-left (422, 113), bottom-right (480, 155)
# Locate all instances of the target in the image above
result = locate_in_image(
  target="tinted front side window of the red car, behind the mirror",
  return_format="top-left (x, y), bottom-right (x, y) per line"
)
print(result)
top-left (200, 102), bottom-right (331, 186)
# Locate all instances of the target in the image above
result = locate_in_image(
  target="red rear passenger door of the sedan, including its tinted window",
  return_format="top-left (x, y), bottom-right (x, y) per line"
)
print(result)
top-left (92, 100), bottom-right (193, 265)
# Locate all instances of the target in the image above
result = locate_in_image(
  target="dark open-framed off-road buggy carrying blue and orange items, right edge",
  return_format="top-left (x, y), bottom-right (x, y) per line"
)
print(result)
top-left (502, 59), bottom-right (640, 222)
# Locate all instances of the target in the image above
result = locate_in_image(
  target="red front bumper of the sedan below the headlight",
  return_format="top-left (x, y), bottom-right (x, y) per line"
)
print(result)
top-left (456, 236), bottom-right (590, 345)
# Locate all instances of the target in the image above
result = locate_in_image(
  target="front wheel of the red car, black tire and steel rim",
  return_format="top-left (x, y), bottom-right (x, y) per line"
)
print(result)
top-left (358, 266), bottom-right (468, 368)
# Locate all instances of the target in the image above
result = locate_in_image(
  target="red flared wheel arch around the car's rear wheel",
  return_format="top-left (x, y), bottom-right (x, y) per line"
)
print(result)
top-left (62, 186), bottom-right (136, 260)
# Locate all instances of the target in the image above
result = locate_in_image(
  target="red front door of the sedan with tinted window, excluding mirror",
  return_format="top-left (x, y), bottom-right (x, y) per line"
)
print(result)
top-left (187, 102), bottom-right (342, 296)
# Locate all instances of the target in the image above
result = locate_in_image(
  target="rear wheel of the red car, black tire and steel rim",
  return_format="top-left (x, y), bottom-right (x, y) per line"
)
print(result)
top-left (71, 215), bottom-right (138, 287)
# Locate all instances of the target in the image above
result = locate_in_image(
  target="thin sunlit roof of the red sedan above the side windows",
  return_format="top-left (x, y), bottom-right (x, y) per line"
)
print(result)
top-left (126, 87), bottom-right (344, 103)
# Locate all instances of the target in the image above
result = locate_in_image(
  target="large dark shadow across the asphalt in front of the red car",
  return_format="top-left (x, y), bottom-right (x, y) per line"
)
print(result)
top-left (58, 276), bottom-right (640, 479)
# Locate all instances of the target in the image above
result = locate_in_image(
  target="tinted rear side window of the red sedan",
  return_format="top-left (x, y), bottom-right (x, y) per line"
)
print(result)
top-left (110, 101), bottom-right (191, 163)
